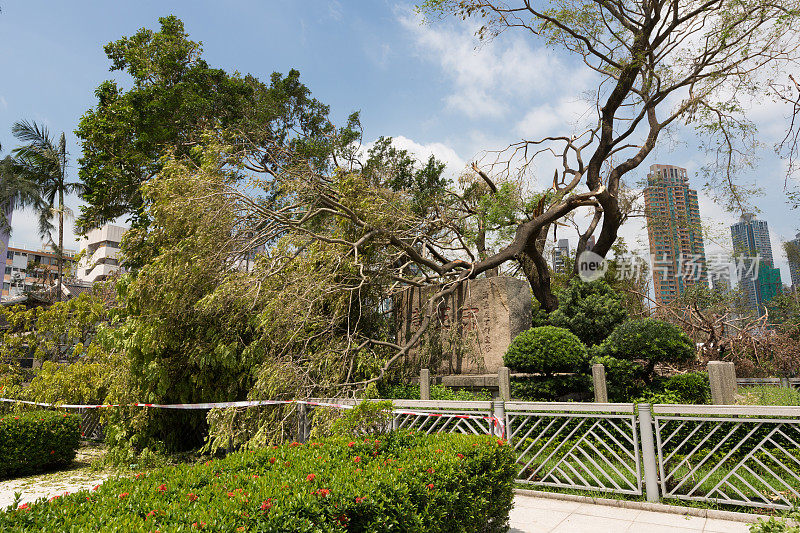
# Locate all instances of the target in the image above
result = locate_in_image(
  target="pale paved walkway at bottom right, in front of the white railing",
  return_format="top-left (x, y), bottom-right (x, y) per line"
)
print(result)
top-left (509, 494), bottom-right (750, 533)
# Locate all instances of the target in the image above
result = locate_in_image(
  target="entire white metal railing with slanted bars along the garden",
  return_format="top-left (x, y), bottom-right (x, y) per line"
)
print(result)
top-left (296, 400), bottom-right (800, 509)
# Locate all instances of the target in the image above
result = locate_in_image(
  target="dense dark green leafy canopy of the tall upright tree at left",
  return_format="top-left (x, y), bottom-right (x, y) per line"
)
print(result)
top-left (76, 16), bottom-right (357, 228)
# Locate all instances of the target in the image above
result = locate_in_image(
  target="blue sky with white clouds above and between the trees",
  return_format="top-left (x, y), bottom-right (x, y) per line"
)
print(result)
top-left (0, 0), bottom-right (800, 283)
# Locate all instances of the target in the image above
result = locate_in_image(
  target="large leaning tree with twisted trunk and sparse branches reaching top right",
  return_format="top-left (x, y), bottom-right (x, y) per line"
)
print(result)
top-left (216, 0), bottom-right (800, 380)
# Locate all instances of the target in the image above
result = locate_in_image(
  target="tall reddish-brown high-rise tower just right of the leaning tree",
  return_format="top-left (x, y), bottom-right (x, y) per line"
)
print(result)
top-left (644, 165), bottom-right (708, 305)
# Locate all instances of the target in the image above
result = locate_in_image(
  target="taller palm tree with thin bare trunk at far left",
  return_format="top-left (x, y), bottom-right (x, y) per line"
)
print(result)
top-left (11, 120), bottom-right (82, 300)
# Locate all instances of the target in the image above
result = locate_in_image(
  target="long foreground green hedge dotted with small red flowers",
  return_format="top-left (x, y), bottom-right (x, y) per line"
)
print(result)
top-left (0, 432), bottom-right (514, 533)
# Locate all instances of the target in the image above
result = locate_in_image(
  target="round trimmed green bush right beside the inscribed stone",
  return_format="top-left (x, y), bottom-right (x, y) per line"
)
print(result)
top-left (503, 326), bottom-right (588, 375)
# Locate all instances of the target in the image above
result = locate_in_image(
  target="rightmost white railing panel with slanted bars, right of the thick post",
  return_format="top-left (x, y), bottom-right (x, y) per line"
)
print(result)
top-left (653, 405), bottom-right (800, 509)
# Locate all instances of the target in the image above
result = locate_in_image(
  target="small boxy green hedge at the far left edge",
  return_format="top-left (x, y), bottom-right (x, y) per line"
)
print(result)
top-left (0, 411), bottom-right (81, 478)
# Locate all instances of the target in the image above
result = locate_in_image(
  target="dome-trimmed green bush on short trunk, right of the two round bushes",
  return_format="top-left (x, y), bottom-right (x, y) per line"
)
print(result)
top-left (599, 318), bottom-right (695, 383)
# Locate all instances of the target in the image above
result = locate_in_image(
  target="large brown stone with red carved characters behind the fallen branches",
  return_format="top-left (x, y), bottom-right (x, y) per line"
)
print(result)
top-left (395, 277), bottom-right (531, 375)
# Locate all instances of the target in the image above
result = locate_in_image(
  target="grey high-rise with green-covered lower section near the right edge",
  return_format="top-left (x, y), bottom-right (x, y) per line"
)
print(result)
top-left (731, 213), bottom-right (781, 315)
